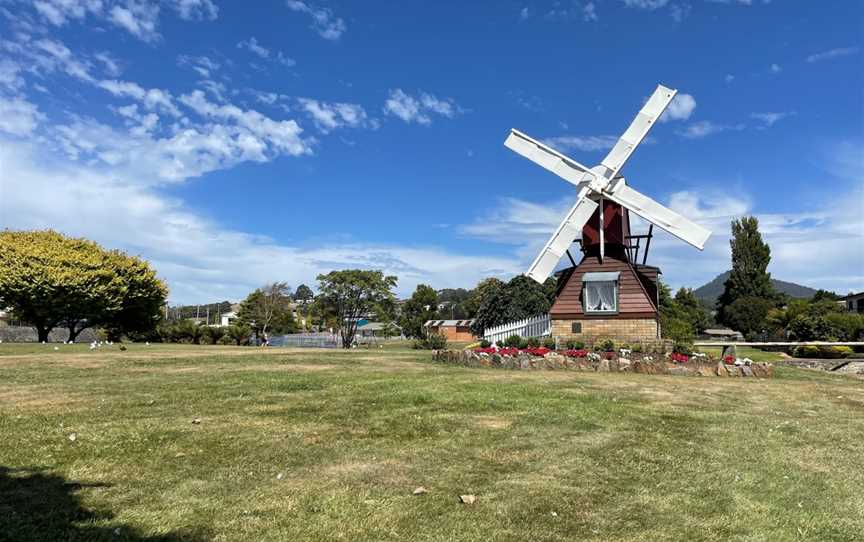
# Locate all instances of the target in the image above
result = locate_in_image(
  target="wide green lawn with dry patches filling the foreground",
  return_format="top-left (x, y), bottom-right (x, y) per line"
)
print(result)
top-left (0, 344), bottom-right (864, 541)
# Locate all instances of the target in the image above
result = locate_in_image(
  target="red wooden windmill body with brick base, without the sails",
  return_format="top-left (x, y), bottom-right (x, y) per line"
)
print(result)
top-left (549, 200), bottom-right (660, 344)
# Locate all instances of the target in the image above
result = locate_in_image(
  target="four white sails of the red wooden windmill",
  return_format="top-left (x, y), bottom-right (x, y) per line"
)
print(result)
top-left (504, 85), bottom-right (711, 283)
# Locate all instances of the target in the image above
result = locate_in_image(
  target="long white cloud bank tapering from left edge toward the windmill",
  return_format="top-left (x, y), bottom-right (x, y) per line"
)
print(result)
top-left (0, 141), bottom-right (520, 303)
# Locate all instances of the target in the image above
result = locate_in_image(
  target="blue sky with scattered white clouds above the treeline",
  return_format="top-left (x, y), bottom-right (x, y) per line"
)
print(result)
top-left (0, 0), bottom-right (864, 303)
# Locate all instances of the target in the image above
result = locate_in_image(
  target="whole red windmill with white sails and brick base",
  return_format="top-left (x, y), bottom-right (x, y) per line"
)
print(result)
top-left (504, 85), bottom-right (711, 345)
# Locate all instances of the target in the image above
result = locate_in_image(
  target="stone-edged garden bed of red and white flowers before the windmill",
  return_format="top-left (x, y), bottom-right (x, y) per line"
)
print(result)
top-left (433, 348), bottom-right (774, 378)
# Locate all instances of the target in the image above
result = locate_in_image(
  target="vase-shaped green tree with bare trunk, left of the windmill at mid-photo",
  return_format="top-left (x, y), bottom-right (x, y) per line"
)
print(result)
top-left (317, 269), bottom-right (396, 348)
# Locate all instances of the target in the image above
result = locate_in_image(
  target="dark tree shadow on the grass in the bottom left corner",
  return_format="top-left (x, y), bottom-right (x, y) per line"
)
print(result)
top-left (0, 466), bottom-right (209, 542)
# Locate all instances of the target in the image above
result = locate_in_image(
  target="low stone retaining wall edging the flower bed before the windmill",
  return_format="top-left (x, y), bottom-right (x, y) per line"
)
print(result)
top-left (432, 350), bottom-right (774, 378)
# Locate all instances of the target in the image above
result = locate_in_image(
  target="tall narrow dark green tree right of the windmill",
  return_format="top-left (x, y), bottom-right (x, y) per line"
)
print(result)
top-left (717, 216), bottom-right (776, 332)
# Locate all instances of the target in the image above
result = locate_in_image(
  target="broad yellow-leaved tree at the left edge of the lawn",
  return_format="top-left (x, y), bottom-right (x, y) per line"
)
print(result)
top-left (0, 230), bottom-right (168, 341)
